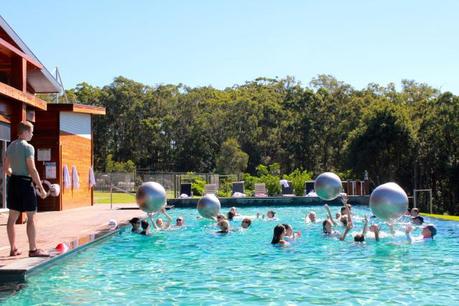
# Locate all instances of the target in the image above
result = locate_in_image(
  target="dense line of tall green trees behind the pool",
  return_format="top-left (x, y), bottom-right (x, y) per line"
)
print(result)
top-left (67, 75), bottom-right (459, 213)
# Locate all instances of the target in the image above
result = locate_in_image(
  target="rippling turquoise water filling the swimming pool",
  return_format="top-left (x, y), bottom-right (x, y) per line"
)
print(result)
top-left (4, 207), bottom-right (459, 305)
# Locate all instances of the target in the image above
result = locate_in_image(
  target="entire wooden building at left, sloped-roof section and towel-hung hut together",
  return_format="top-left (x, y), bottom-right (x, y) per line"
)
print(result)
top-left (0, 16), bottom-right (105, 210)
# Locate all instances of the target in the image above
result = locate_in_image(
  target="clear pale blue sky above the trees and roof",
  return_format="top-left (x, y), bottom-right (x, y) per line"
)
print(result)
top-left (0, 0), bottom-right (459, 94)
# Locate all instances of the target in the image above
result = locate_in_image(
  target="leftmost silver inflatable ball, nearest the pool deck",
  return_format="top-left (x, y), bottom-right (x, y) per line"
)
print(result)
top-left (135, 182), bottom-right (166, 213)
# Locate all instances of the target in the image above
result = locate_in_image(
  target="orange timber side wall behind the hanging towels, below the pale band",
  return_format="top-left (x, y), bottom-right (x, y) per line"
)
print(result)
top-left (60, 133), bottom-right (92, 209)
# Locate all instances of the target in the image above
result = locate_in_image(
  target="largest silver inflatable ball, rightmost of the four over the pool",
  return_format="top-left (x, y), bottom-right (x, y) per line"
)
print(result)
top-left (370, 183), bottom-right (408, 221)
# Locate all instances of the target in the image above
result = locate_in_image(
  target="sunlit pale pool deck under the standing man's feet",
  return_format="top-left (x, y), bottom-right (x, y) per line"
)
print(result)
top-left (0, 204), bottom-right (145, 283)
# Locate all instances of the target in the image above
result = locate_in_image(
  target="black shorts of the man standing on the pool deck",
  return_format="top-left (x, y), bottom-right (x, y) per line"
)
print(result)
top-left (6, 175), bottom-right (37, 212)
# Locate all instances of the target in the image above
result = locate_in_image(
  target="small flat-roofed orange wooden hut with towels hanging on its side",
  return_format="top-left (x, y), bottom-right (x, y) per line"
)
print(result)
top-left (31, 103), bottom-right (105, 211)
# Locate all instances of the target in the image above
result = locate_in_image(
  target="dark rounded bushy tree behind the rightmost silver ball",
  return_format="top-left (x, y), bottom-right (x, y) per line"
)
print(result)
top-left (347, 101), bottom-right (416, 190)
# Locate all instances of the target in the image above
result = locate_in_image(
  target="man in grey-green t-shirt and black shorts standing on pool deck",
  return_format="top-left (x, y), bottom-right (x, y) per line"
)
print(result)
top-left (3, 121), bottom-right (49, 257)
